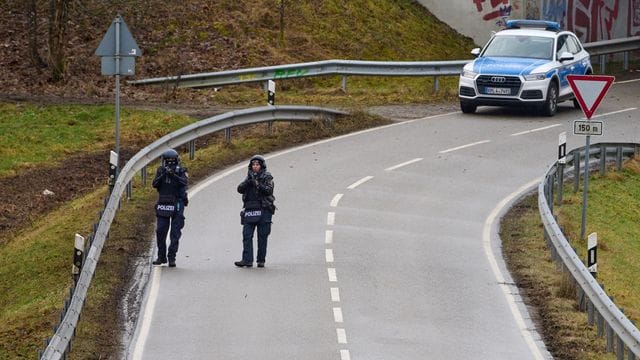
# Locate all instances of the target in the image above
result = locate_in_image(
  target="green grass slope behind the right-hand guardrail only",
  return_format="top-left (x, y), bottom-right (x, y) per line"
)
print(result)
top-left (559, 163), bottom-right (640, 322)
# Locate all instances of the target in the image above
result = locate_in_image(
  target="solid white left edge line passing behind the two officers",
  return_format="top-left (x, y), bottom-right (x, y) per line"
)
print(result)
top-left (134, 111), bottom-right (459, 360)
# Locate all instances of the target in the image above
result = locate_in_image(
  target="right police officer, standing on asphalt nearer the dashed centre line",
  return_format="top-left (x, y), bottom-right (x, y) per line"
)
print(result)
top-left (235, 155), bottom-right (276, 267)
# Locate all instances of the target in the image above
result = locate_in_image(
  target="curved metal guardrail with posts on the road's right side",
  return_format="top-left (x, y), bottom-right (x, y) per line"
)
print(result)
top-left (538, 143), bottom-right (640, 359)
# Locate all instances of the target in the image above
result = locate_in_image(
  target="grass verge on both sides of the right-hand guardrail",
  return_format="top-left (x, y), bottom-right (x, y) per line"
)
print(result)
top-left (500, 161), bottom-right (640, 359)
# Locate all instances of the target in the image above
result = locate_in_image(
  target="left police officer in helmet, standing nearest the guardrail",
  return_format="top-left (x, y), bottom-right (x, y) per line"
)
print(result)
top-left (153, 149), bottom-right (189, 267)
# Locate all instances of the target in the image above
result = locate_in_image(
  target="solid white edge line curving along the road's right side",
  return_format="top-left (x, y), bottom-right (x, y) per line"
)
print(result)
top-left (482, 178), bottom-right (544, 360)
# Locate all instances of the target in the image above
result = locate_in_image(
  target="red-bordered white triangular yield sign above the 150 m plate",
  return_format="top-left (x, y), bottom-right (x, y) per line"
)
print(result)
top-left (567, 75), bottom-right (616, 119)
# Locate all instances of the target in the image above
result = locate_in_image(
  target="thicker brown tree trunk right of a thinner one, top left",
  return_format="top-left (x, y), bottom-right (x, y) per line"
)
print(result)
top-left (49, 0), bottom-right (69, 82)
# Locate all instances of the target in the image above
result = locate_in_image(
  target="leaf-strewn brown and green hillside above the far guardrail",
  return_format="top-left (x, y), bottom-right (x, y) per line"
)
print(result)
top-left (0, 0), bottom-right (473, 102)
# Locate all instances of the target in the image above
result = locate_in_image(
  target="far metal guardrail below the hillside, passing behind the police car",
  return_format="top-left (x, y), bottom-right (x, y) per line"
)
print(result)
top-left (129, 36), bottom-right (640, 90)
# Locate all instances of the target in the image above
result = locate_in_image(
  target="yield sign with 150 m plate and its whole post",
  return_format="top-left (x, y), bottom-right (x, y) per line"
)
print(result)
top-left (567, 75), bottom-right (615, 239)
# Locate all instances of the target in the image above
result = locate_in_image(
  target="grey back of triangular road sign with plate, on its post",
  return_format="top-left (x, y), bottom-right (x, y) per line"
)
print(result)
top-left (96, 15), bottom-right (142, 183)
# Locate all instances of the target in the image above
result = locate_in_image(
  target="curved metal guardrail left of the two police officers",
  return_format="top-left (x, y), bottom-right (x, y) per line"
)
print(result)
top-left (40, 106), bottom-right (346, 360)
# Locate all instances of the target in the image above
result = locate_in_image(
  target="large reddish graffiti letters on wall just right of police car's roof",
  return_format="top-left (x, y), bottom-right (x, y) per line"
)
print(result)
top-left (567, 0), bottom-right (616, 42)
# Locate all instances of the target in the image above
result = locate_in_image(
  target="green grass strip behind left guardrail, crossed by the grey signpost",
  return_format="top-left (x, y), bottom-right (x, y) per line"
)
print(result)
top-left (0, 103), bottom-right (193, 177)
